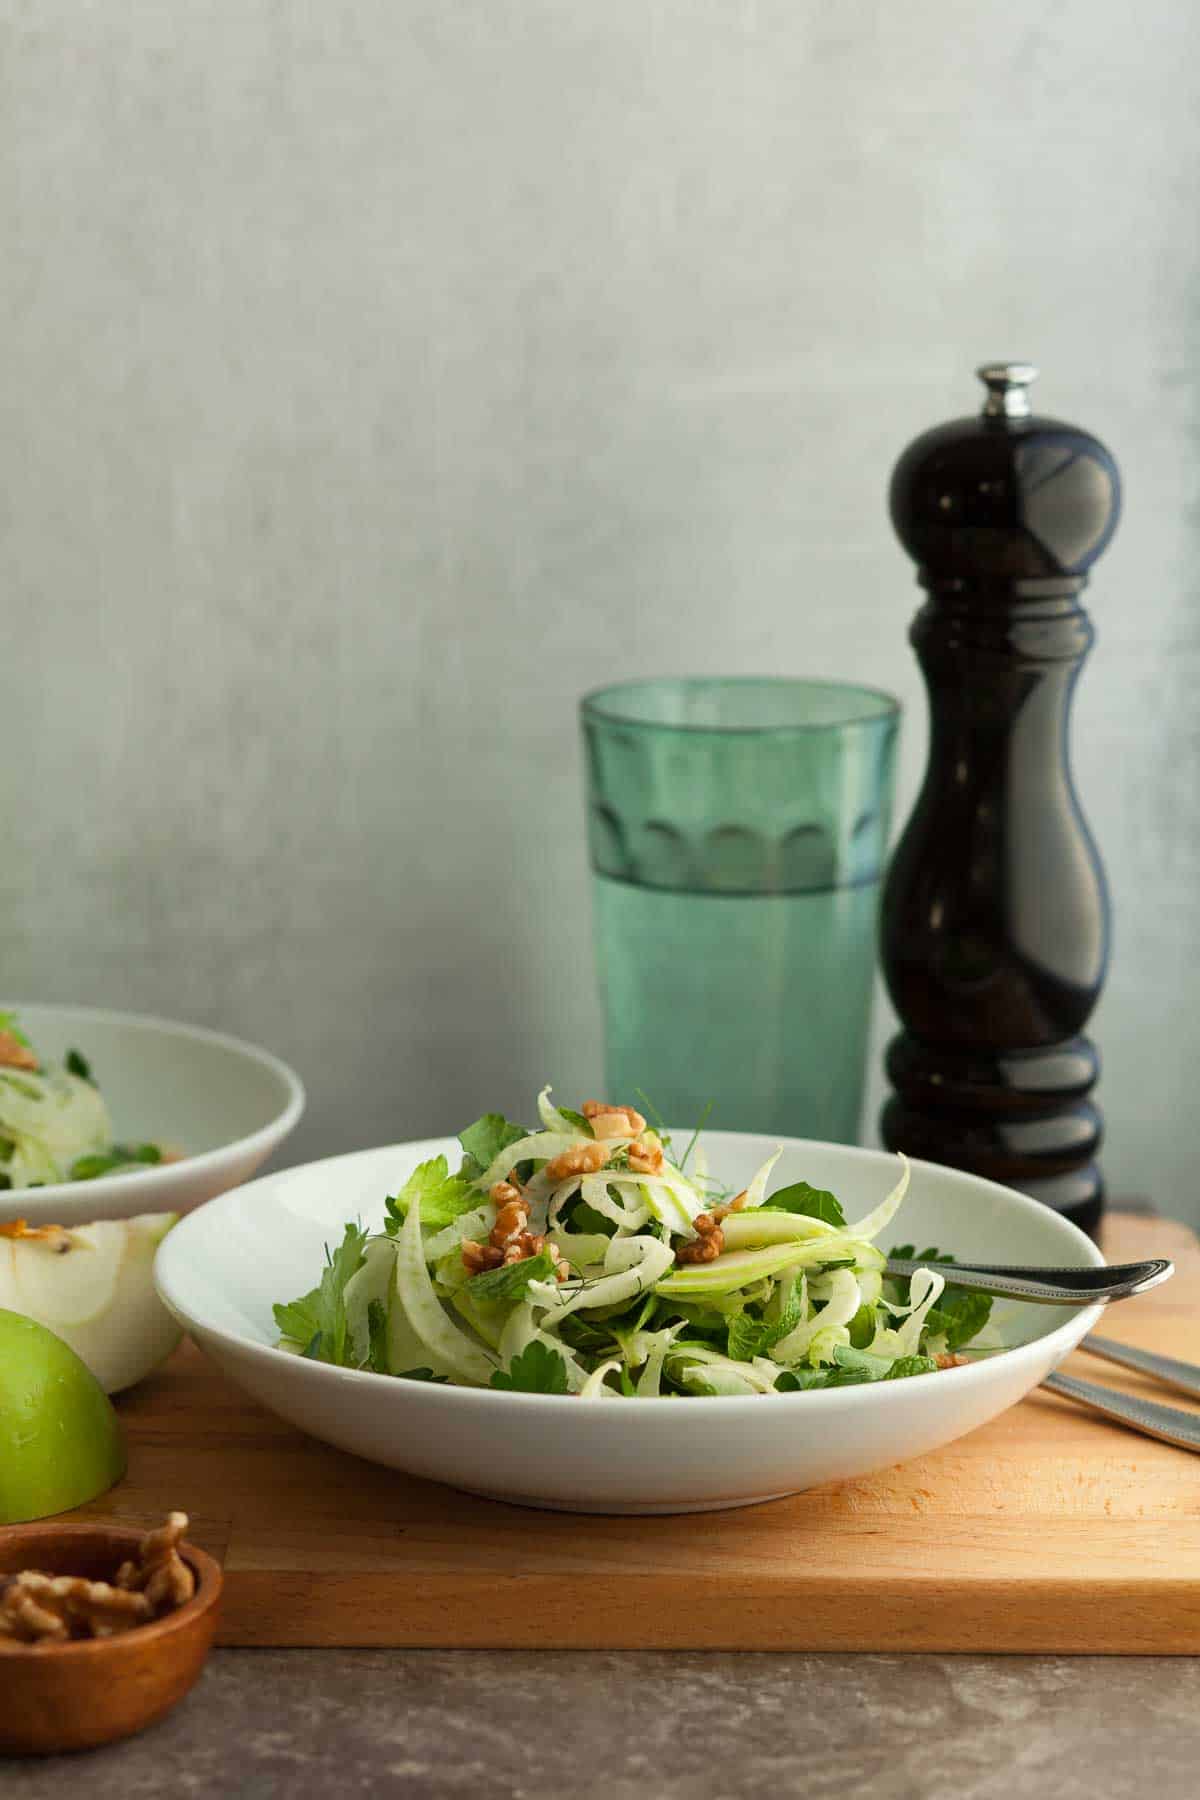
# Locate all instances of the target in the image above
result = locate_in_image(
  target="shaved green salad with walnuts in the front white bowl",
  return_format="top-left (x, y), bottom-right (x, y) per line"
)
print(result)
top-left (275, 1089), bottom-right (991, 1399)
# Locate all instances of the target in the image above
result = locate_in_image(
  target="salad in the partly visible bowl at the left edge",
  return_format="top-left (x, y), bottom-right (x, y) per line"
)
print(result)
top-left (0, 1012), bottom-right (169, 1190)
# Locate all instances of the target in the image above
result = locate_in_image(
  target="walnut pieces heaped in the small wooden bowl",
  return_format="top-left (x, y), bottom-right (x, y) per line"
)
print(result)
top-left (0, 1512), bottom-right (196, 1643)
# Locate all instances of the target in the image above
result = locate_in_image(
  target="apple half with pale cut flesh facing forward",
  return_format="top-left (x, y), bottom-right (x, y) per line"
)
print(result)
top-left (0, 1213), bottom-right (180, 1393)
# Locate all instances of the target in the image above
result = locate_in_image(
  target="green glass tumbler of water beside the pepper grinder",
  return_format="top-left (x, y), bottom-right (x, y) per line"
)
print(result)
top-left (581, 679), bottom-right (900, 1143)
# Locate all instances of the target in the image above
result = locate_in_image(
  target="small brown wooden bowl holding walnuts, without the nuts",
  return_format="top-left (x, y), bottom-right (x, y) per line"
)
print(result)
top-left (0, 1525), bottom-right (221, 1757)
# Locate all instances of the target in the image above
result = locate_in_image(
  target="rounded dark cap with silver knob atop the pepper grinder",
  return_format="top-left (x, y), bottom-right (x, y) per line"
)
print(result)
top-left (891, 362), bottom-right (1121, 586)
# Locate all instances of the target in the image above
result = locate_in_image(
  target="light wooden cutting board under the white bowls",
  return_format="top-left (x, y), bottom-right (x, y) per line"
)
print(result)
top-left (61, 1215), bottom-right (1200, 1652)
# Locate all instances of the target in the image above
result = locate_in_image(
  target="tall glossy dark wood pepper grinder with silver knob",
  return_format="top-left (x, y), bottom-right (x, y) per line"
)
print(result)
top-left (882, 362), bottom-right (1121, 1231)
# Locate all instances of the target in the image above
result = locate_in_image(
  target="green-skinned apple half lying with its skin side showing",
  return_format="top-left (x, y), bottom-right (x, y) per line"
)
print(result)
top-left (0, 1310), bottom-right (124, 1525)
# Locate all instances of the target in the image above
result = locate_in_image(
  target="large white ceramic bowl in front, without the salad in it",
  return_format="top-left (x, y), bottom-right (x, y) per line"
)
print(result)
top-left (155, 1132), bottom-right (1103, 1512)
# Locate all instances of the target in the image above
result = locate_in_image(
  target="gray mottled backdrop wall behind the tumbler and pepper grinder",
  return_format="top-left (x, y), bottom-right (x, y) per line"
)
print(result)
top-left (0, 0), bottom-right (1200, 1217)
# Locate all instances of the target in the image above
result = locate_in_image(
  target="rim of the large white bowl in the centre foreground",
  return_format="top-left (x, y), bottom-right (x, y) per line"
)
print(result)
top-left (155, 1127), bottom-right (1105, 1418)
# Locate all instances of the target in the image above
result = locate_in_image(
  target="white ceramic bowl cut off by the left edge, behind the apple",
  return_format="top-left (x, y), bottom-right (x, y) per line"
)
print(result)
top-left (0, 1001), bottom-right (304, 1231)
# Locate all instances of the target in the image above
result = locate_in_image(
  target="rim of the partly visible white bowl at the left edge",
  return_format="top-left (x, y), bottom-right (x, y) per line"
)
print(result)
top-left (0, 999), bottom-right (308, 1220)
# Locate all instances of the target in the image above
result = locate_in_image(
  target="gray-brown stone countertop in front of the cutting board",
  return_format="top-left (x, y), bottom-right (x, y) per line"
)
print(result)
top-left (0, 1651), bottom-right (1200, 1800)
